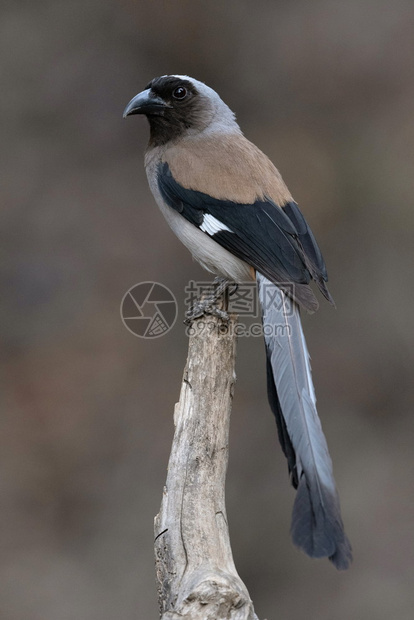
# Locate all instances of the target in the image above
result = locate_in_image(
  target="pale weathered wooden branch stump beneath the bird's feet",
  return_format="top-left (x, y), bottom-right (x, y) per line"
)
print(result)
top-left (155, 316), bottom-right (258, 620)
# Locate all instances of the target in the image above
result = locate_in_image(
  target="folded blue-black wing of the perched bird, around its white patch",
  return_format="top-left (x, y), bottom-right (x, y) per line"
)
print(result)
top-left (158, 162), bottom-right (327, 310)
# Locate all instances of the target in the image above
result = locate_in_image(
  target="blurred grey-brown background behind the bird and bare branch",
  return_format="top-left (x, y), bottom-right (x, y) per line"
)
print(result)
top-left (0, 0), bottom-right (414, 620)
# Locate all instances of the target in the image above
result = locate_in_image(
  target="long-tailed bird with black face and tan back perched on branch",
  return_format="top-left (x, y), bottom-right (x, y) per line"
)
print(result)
top-left (123, 75), bottom-right (352, 570)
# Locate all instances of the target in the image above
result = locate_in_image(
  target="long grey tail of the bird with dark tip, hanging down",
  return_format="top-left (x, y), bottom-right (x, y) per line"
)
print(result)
top-left (257, 273), bottom-right (352, 569)
